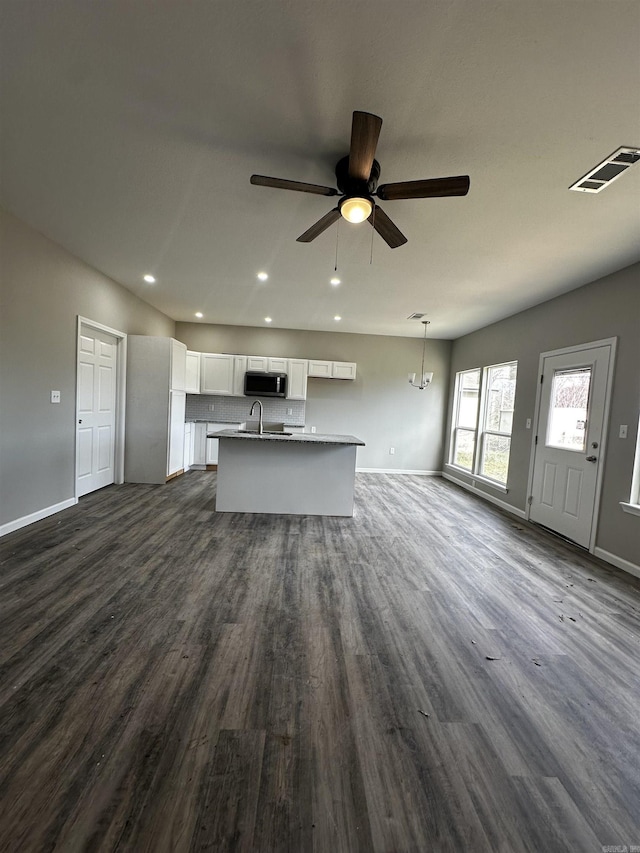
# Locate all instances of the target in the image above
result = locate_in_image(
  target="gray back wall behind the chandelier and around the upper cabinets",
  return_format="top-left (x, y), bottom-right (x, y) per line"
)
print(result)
top-left (176, 323), bottom-right (451, 471)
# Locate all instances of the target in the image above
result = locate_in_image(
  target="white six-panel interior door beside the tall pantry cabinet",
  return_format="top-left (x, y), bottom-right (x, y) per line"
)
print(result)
top-left (76, 324), bottom-right (118, 497)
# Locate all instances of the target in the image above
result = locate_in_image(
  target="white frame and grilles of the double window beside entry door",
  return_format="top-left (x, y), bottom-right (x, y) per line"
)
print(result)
top-left (448, 359), bottom-right (518, 492)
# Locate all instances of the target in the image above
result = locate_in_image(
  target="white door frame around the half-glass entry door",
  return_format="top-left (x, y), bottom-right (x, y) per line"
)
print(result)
top-left (526, 337), bottom-right (618, 554)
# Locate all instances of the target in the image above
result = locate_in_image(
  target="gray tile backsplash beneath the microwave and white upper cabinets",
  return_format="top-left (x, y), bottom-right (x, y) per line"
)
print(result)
top-left (185, 394), bottom-right (305, 426)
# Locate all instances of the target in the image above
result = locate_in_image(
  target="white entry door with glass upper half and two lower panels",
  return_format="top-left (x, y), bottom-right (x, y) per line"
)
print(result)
top-left (529, 344), bottom-right (612, 548)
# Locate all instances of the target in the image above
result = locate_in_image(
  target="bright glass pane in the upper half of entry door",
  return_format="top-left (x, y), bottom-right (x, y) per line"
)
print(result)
top-left (547, 367), bottom-right (591, 453)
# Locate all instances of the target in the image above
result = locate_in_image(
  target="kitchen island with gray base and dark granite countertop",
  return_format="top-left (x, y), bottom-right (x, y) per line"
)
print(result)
top-left (207, 429), bottom-right (364, 516)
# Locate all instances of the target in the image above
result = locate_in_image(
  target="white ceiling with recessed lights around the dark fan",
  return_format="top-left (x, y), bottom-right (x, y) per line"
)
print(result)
top-left (0, 0), bottom-right (640, 338)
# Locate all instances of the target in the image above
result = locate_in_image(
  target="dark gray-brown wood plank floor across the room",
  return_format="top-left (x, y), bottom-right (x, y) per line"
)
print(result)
top-left (0, 472), bottom-right (640, 853)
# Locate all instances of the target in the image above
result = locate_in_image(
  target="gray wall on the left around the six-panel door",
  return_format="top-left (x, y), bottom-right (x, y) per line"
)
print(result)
top-left (0, 211), bottom-right (174, 525)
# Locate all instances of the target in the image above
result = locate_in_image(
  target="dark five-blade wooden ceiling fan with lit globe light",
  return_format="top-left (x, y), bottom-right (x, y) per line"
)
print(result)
top-left (251, 110), bottom-right (469, 249)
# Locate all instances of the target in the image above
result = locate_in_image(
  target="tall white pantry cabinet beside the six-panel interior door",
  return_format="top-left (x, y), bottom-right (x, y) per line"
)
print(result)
top-left (124, 335), bottom-right (187, 483)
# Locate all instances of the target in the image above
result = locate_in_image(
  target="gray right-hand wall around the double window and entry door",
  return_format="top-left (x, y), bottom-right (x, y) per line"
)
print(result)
top-left (449, 264), bottom-right (640, 564)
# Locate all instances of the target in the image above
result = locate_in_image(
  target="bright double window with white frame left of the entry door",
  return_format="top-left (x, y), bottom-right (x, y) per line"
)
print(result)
top-left (450, 361), bottom-right (518, 485)
